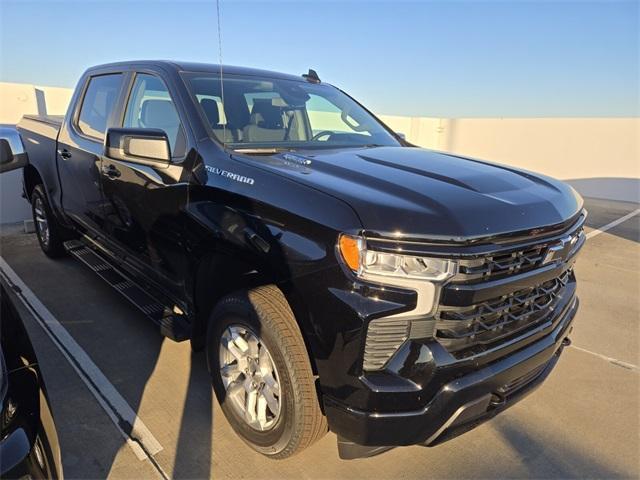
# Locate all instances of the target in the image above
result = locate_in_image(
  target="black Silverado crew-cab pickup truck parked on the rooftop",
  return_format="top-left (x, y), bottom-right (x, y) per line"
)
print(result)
top-left (13, 61), bottom-right (586, 458)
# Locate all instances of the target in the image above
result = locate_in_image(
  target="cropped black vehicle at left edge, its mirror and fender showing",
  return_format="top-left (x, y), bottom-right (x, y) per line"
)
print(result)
top-left (0, 128), bottom-right (62, 479)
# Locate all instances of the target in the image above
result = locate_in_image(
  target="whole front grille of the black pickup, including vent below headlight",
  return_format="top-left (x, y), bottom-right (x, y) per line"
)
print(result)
top-left (363, 218), bottom-right (585, 371)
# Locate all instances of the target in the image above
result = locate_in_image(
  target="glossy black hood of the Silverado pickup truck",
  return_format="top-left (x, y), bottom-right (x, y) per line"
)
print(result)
top-left (238, 147), bottom-right (582, 241)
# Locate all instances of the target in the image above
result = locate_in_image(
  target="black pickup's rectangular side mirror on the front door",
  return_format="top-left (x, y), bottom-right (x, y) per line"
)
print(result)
top-left (104, 128), bottom-right (171, 166)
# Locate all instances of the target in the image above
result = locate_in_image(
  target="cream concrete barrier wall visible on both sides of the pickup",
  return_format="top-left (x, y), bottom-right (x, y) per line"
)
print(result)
top-left (0, 82), bottom-right (640, 223)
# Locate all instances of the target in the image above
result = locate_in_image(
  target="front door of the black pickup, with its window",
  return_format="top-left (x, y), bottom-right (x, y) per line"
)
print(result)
top-left (102, 72), bottom-right (189, 299)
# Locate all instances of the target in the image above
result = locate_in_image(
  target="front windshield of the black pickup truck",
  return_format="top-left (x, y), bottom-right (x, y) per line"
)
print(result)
top-left (181, 73), bottom-right (400, 151)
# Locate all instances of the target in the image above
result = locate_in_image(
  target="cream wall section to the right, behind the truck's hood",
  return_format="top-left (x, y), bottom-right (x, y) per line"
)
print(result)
top-left (381, 115), bottom-right (640, 202)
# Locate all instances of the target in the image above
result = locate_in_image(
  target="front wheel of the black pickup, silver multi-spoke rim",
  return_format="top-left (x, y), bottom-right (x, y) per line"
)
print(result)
top-left (206, 285), bottom-right (327, 459)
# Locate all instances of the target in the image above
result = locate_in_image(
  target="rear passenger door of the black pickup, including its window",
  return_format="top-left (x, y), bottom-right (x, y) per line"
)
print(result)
top-left (57, 73), bottom-right (125, 232)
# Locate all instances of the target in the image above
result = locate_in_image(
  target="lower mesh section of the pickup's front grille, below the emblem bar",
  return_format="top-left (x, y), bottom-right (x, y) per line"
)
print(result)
top-left (435, 270), bottom-right (572, 358)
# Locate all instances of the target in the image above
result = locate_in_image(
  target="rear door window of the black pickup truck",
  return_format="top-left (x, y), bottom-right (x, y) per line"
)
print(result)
top-left (78, 73), bottom-right (122, 140)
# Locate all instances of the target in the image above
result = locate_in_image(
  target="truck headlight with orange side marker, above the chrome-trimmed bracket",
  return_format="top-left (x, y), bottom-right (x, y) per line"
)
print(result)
top-left (338, 235), bottom-right (457, 282)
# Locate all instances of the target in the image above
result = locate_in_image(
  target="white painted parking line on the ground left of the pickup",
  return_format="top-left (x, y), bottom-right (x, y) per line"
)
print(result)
top-left (0, 256), bottom-right (169, 478)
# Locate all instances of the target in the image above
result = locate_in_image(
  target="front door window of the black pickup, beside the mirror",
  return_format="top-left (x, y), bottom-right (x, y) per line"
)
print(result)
top-left (123, 73), bottom-right (186, 157)
